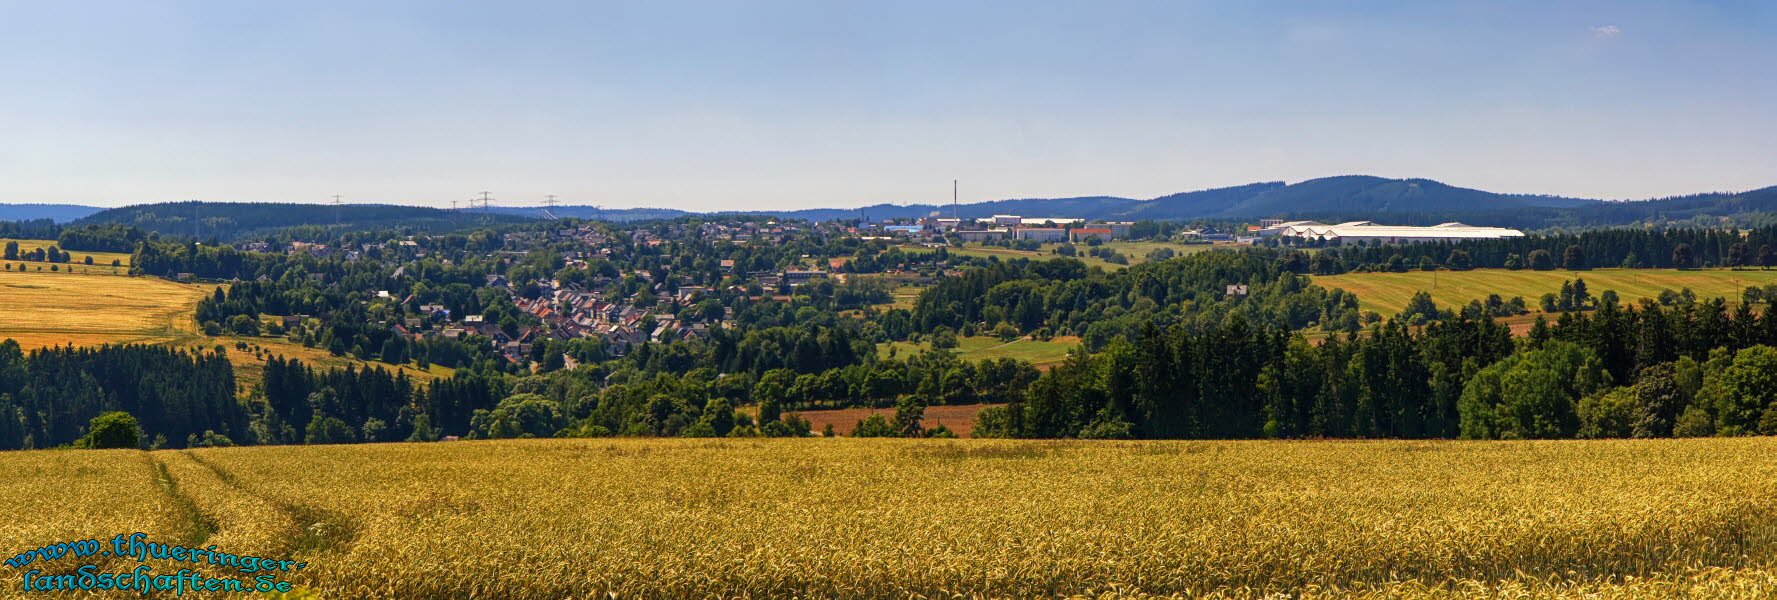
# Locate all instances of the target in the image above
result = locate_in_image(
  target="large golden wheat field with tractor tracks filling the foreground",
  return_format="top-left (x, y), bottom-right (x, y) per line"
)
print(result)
top-left (0, 438), bottom-right (1777, 598)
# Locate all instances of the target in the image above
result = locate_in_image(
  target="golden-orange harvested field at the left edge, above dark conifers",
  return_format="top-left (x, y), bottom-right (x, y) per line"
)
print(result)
top-left (0, 272), bottom-right (213, 348)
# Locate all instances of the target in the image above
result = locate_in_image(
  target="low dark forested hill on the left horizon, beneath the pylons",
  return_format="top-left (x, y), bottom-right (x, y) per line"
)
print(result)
top-left (75, 202), bottom-right (535, 240)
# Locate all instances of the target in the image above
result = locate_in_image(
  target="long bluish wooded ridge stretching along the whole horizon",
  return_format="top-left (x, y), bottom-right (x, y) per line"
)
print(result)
top-left (13, 176), bottom-right (1777, 236)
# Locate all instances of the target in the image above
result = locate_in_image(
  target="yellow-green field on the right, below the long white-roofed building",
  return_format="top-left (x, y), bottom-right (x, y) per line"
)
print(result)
top-left (1315, 268), bottom-right (1777, 314)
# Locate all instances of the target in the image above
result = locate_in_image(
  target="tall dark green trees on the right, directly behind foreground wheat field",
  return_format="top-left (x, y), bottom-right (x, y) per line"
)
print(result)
top-left (976, 298), bottom-right (1777, 438)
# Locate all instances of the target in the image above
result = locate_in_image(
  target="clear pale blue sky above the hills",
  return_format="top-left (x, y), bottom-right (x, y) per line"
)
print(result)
top-left (0, 0), bottom-right (1777, 209)
